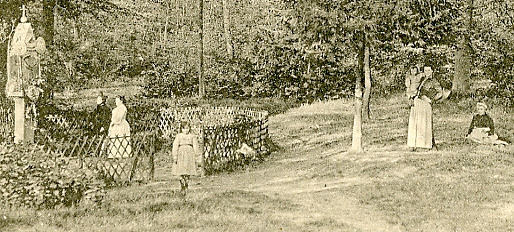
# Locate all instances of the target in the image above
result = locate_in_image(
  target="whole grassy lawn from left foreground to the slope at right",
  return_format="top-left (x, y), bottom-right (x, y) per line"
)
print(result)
top-left (0, 97), bottom-right (514, 231)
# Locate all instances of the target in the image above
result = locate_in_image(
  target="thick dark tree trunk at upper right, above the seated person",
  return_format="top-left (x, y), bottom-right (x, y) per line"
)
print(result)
top-left (452, 0), bottom-right (473, 98)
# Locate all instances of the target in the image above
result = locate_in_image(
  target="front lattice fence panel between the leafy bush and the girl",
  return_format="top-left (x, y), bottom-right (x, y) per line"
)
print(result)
top-left (38, 133), bottom-right (156, 182)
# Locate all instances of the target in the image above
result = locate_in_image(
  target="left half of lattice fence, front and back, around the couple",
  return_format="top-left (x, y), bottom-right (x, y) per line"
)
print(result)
top-left (35, 105), bottom-right (158, 182)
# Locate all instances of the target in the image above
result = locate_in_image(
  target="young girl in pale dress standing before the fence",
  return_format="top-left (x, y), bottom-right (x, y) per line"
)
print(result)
top-left (171, 122), bottom-right (198, 196)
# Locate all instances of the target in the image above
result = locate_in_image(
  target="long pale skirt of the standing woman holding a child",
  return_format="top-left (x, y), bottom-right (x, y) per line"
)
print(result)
top-left (407, 98), bottom-right (433, 148)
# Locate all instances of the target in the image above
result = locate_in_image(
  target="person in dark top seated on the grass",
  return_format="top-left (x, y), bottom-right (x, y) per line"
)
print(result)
top-left (466, 102), bottom-right (507, 145)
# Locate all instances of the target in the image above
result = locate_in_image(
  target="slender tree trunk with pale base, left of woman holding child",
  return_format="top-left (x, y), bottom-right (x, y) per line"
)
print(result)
top-left (350, 31), bottom-right (365, 153)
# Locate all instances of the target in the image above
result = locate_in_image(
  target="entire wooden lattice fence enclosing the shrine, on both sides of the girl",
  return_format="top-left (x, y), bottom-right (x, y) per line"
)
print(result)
top-left (0, 100), bottom-right (269, 180)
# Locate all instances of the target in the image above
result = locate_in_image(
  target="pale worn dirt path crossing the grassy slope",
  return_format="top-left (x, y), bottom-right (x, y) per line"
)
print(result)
top-left (196, 101), bottom-right (404, 231)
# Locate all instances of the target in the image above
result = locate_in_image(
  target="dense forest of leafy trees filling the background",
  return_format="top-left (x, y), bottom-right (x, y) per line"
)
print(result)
top-left (0, 0), bottom-right (514, 105)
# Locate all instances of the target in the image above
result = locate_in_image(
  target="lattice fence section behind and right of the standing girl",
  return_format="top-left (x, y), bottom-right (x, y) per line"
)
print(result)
top-left (159, 107), bottom-right (269, 175)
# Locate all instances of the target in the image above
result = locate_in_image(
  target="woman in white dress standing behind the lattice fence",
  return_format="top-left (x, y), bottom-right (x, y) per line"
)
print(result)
top-left (108, 96), bottom-right (132, 158)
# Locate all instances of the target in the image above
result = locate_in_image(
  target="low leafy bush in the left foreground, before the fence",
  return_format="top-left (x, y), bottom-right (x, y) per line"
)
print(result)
top-left (0, 144), bottom-right (105, 208)
